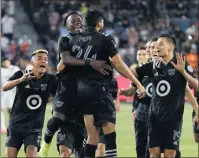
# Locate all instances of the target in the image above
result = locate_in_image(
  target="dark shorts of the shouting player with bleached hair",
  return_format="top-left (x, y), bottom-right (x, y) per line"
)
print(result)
top-left (5, 129), bottom-right (42, 151)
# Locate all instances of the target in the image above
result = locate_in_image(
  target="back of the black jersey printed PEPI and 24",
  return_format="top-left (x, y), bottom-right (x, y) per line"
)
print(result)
top-left (71, 30), bottom-right (117, 83)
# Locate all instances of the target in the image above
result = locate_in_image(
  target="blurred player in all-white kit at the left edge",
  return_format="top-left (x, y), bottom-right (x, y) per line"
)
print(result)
top-left (1, 57), bottom-right (19, 134)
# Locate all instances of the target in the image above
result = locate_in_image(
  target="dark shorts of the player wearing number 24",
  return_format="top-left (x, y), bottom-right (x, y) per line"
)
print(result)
top-left (78, 95), bottom-right (116, 127)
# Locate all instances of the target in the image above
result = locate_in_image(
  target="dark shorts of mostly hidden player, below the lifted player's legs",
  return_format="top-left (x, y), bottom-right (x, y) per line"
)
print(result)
top-left (57, 123), bottom-right (86, 151)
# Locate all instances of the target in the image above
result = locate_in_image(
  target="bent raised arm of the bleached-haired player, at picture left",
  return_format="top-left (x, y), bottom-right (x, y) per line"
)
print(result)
top-left (2, 71), bottom-right (35, 91)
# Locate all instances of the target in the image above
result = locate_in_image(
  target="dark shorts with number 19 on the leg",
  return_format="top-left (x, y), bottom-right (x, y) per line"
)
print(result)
top-left (149, 113), bottom-right (182, 150)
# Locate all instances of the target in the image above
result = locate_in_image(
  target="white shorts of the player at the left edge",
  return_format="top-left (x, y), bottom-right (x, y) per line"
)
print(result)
top-left (1, 91), bottom-right (15, 109)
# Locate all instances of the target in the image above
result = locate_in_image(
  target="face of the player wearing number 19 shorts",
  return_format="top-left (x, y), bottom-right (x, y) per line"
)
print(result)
top-left (157, 37), bottom-right (171, 58)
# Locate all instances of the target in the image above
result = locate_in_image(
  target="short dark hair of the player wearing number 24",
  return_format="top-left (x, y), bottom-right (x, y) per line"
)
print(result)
top-left (85, 7), bottom-right (104, 27)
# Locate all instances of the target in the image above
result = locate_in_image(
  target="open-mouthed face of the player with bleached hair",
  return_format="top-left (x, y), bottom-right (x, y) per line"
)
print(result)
top-left (32, 53), bottom-right (48, 74)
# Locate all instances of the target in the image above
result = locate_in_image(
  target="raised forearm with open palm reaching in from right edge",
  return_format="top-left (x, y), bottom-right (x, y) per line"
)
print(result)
top-left (171, 53), bottom-right (199, 91)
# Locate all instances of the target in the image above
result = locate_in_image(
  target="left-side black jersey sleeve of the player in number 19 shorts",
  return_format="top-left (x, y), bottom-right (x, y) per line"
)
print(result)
top-left (135, 62), bottom-right (153, 79)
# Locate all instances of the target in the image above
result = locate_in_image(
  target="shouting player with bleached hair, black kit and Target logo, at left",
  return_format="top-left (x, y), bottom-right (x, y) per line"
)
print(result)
top-left (3, 49), bottom-right (57, 157)
